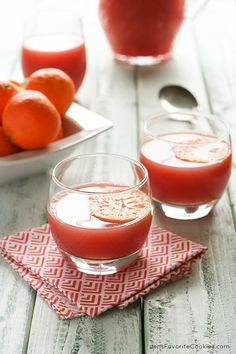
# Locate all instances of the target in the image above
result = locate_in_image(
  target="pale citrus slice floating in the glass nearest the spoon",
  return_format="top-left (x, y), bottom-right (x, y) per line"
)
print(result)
top-left (172, 137), bottom-right (230, 163)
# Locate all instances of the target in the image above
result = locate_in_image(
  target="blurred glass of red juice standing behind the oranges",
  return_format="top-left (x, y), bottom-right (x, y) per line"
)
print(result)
top-left (21, 10), bottom-right (86, 90)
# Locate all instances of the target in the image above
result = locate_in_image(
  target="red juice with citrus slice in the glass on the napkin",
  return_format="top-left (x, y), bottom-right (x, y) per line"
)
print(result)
top-left (48, 184), bottom-right (152, 260)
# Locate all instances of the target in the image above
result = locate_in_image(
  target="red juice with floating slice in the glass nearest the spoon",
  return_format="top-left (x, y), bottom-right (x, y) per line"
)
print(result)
top-left (140, 132), bottom-right (232, 205)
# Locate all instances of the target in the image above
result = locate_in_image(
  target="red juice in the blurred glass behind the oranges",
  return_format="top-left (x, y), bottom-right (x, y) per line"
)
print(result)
top-left (21, 34), bottom-right (86, 90)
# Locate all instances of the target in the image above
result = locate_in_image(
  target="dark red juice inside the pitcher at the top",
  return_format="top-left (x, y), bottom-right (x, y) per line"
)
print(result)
top-left (99, 0), bottom-right (184, 56)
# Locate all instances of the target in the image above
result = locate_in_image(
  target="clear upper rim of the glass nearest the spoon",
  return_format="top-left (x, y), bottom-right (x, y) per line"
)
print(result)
top-left (144, 110), bottom-right (230, 146)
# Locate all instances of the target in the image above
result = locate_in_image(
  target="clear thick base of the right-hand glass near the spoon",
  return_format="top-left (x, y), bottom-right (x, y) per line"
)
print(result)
top-left (154, 200), bottom-right (216, 220)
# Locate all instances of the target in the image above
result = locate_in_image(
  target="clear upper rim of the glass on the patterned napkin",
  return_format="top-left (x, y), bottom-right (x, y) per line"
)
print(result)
top-left (52, 153), bottom-right (149, 196)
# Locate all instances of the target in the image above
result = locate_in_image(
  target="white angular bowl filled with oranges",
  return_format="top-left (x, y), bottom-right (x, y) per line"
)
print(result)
top-left (0, 68), bottom-right (113, 184)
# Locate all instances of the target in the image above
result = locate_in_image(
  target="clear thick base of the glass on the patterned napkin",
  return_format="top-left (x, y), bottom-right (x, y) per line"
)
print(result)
top-left (60, 250), bottom-right (141, 275)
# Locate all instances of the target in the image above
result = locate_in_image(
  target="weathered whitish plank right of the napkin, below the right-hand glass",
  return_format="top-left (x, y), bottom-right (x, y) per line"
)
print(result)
top-left (145, 195), bottom-right (236, 353)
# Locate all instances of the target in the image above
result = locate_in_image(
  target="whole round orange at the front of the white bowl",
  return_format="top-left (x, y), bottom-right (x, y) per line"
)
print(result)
top-left (2, 90), bottom-right (61, 150)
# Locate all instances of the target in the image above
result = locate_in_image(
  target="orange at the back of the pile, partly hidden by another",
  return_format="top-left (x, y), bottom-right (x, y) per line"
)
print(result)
top-left (25, 68), bottom-right (75, 116)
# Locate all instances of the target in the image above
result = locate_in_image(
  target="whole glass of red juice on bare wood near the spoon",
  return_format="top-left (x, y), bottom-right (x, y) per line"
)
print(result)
top-left (140, 111), bottom-right (232, 220)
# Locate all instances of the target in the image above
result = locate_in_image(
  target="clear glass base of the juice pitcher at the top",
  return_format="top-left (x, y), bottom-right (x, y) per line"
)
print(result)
top-left (115, 53), bottom-right (170, 66)
